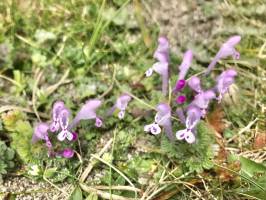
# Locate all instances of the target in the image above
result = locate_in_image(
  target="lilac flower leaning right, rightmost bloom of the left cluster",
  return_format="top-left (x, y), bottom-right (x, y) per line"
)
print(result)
top-left (69, 99), bottom-right (102, 129)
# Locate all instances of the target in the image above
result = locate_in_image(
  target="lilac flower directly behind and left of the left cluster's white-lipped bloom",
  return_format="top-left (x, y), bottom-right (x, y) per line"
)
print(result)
top-left (50, 101), bottom-right (65, 132)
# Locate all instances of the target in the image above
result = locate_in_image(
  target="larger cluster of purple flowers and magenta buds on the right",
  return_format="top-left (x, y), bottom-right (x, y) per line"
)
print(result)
top-left (144, 36), bottom-right (241, 143)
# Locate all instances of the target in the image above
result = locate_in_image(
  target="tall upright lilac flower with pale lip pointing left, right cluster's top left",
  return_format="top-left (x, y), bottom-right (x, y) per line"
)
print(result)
top-left (145, 37), bottom-right (169, 95)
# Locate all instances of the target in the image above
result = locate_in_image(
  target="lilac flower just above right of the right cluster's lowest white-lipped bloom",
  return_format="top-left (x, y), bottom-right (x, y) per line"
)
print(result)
top-left (191, 90), bottom-right (216, 117)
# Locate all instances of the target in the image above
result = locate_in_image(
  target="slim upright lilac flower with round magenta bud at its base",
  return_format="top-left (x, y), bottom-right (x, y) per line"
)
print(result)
top-left (174, 50), bottom-right (193, 91)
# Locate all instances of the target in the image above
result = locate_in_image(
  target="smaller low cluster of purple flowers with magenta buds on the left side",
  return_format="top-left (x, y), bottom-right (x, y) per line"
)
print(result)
top-left (32, 99), bottom-right (102, 158)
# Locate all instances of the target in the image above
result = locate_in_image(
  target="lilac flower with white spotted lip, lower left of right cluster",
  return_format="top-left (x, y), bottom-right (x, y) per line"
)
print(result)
top-left (144, 103), bottom-right (173, 140)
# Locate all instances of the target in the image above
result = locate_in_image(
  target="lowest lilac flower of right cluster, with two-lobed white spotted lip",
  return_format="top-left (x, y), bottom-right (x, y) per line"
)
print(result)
top-left (176, 106), bottom-right (201, 144)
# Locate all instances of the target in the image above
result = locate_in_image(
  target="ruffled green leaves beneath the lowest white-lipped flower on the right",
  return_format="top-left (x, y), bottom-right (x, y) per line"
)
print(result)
top-left (161, 121), bottom-right (214, 172)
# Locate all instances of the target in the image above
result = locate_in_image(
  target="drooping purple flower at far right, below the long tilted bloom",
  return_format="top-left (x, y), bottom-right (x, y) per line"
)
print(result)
top-left (216, 69), bottom-right (237, 103)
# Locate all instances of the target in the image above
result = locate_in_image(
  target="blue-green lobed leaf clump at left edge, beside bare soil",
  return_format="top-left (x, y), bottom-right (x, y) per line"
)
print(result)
top-left (0, 141), bottom-right (15, 183)
